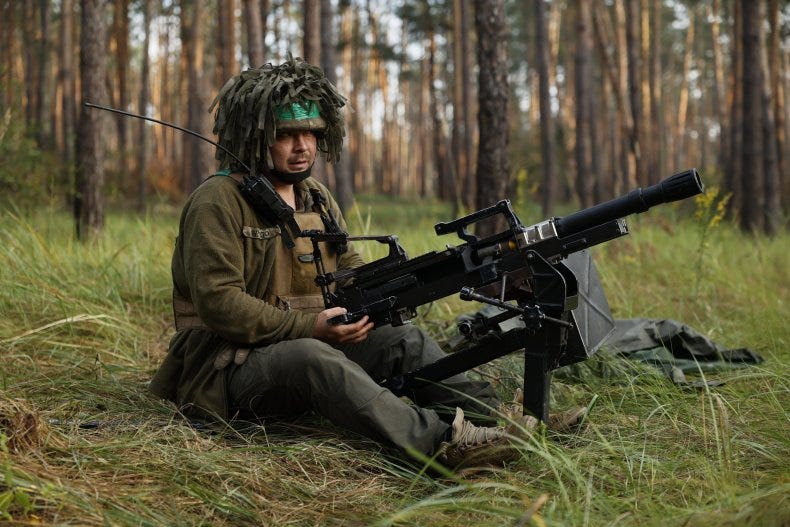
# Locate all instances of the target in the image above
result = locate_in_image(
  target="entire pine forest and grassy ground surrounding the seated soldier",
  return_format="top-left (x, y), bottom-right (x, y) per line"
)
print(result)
top-left (0, 5), bottom-right (790, 527)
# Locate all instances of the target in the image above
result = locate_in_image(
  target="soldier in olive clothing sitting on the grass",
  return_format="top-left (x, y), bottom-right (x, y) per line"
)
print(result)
top-left (151, 58), bottom-right (580, 465)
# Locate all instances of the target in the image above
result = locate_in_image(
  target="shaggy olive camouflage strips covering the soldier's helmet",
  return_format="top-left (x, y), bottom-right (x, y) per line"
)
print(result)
top-left (209, 57), bottom-right (346, 173)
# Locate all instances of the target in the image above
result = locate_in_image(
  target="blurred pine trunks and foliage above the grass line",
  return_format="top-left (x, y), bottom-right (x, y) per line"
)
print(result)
top-left (0, 0), bottom-right (790, 237)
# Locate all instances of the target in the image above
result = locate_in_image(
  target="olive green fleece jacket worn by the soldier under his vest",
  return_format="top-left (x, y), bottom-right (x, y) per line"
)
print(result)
top-left (150, 175), bottom-right (363, 419)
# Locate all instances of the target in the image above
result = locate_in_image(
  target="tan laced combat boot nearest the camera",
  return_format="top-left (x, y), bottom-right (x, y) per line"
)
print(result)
top-left (438, 408), bottom-right (538, 468)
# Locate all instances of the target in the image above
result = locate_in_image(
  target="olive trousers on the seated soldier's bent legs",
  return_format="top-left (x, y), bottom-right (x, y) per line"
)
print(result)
top-left (227, 325), bottom-right (498, 455)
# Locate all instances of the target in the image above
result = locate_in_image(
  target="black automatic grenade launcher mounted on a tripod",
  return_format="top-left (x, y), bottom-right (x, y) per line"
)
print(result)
top-left (302, 169), bottom-right (703, 420)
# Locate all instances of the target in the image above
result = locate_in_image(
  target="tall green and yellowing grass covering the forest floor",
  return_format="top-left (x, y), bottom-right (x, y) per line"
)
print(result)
top-left (0, 198), bottom-right (790, 526)
